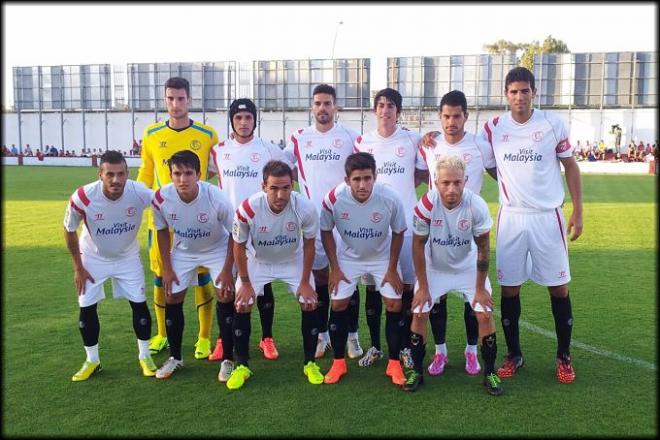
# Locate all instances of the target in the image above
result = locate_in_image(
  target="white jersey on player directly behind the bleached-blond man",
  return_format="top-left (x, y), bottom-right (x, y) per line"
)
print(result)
top-left (419, 133), bottom-right (495, 194)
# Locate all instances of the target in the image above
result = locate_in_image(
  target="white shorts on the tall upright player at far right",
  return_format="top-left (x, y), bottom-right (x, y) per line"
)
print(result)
top-left (495, 207), bottom-right (571, 286)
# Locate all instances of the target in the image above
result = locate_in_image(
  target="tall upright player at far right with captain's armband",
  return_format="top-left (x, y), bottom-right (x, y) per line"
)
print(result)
top-left (481, 67), bottom-right (582, 383)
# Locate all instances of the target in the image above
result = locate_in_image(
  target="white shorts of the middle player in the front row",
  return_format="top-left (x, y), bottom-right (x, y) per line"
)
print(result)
top-left (236, 257), bottom-right (315, 304)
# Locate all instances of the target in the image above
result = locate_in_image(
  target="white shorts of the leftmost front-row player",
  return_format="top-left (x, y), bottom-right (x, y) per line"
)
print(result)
top-left (78, 253), bottom-right (147, 307)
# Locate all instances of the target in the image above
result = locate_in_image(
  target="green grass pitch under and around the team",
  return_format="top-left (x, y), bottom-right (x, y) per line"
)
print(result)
top-left (2, 167), bottom-right (657, 437)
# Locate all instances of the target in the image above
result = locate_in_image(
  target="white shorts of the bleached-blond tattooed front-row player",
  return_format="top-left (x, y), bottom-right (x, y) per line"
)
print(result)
top-left (413, 265), bottom-right (493, 313)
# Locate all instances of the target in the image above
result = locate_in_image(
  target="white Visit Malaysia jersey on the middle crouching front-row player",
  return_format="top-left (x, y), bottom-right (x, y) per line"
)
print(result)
top-left (232, 191), bottom-right (319, 262)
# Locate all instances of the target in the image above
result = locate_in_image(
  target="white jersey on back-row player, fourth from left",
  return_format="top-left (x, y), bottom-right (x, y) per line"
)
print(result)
top-left (354, 127), bottom-right (427, 235)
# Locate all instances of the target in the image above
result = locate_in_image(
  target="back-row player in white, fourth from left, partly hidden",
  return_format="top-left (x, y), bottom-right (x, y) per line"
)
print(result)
top-left (355, 88), bottom-right (428, 366)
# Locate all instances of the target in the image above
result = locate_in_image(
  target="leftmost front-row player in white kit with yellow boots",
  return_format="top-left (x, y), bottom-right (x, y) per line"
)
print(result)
top-left (64, 151), bottom-right (156, 382)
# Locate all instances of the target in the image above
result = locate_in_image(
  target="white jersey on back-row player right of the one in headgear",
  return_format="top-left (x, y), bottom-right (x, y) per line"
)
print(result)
top-left (284, 124), bottom-right (358, 213)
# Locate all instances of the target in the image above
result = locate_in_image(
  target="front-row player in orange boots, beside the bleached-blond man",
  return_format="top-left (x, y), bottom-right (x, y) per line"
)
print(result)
top-left (321, 153), bottom-right (407, 385)
